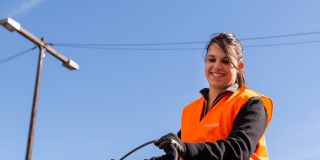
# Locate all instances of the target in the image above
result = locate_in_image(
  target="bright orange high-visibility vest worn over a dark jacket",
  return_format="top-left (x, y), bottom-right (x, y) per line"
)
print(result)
top-left (181, 88), bottom-right (273, 160)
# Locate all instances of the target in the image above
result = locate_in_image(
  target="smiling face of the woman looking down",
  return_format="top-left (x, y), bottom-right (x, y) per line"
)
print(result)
top-left (204, 43), bottom-right (238, 91)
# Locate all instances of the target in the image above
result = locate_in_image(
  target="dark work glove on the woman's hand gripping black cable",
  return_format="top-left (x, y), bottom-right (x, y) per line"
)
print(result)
top-left (154, 133), bottom-right (187, 159)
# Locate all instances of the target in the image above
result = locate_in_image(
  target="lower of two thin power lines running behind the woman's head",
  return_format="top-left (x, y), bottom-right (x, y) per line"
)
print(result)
top-left (55, 40), bottom-right (320, 51)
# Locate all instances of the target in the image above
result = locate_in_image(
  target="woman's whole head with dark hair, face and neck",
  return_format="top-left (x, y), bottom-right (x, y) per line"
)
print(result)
top-left (205, 33), bottom-right (247, 112)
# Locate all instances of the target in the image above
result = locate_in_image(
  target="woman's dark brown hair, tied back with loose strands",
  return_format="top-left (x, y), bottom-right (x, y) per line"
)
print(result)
top-left (206, 32), bottom-right (247, 88)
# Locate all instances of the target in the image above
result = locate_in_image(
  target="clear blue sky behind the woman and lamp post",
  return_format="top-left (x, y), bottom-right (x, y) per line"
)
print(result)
top-left (0, 0), bottom-right (320, 160)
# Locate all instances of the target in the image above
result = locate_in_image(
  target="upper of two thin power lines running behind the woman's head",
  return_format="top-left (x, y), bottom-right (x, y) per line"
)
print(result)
top-left (50, 31), bottom-right (320, 47)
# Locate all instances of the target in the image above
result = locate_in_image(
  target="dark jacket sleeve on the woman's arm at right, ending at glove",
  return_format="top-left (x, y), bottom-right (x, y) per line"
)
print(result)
top-left (184, 97), bottom-right (268, 160)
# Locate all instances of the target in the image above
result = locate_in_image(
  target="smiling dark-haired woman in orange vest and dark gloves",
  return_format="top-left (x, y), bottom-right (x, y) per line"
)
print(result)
top-left (152, 33), bottom-right (273, 160)
